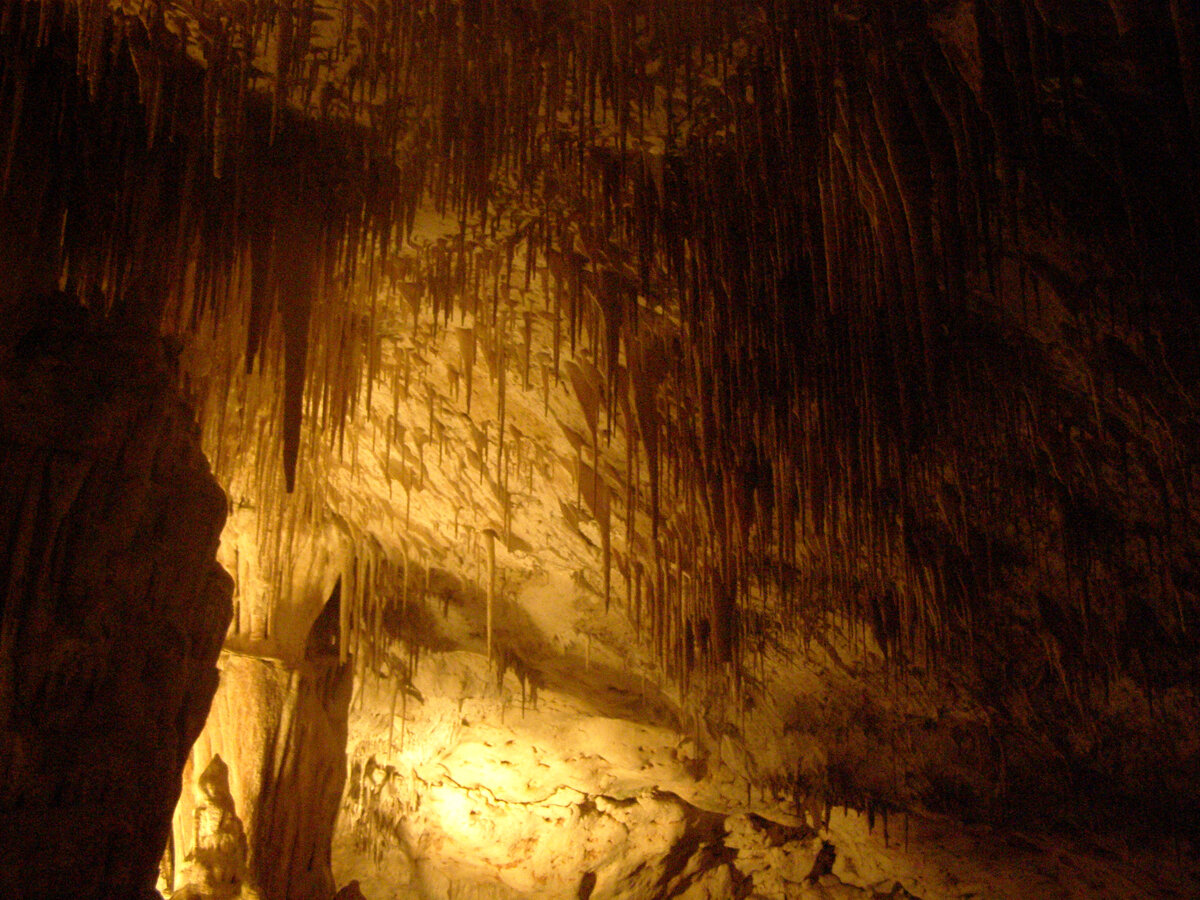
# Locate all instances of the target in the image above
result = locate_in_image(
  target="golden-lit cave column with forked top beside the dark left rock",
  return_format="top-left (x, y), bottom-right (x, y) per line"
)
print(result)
top-left (164, 509), bottom-right (352, 900)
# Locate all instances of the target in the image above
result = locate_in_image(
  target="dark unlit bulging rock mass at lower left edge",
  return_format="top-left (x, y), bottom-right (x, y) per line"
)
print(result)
top-left (0, 300), bottom-right (232, 900)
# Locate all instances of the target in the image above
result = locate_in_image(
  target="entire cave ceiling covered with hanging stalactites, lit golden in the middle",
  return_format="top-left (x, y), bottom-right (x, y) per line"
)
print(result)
top-left (0, 0), bottom-right (1200, 840)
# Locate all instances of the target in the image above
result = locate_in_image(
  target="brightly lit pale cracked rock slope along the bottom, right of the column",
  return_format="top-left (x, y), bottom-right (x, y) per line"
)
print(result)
top-left (334, 628), bottom-right (1194, 900)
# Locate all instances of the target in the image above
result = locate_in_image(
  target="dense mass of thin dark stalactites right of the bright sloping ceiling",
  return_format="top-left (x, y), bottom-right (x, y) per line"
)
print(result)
top-left (316, 0), bottom-right (1195, 695)
